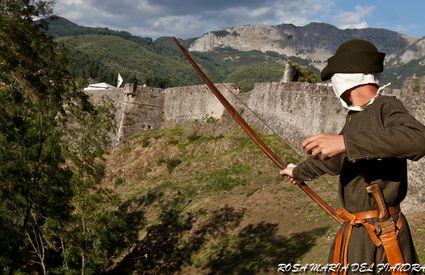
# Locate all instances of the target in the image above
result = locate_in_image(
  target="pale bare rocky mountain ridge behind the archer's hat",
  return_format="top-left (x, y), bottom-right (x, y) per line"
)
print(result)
top-left (189, 23), bottom-right (425, 70)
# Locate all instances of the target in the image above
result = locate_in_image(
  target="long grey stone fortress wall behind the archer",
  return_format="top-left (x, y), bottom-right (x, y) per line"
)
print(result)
top-left (85, 79), bottom-right (425, 212)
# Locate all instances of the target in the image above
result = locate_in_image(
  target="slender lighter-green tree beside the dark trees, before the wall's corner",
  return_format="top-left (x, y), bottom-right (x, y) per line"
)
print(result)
top-left (56, 99), bottom-right (119, 274)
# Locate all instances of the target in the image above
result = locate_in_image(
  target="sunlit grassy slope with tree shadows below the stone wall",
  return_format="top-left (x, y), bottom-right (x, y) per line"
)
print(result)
top-left (100, 121), bottom-right (425, 274)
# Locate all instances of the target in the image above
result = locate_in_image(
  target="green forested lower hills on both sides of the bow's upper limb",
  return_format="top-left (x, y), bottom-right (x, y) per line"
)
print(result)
top-left (47, 17), bottom-right (317, 91)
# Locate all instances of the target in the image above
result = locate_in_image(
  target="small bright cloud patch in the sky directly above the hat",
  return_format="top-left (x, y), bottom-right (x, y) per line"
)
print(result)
top-left (331, 6), bottom-right (375, 29)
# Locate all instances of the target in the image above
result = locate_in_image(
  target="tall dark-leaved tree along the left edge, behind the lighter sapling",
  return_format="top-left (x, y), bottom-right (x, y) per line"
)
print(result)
top-left (0, 1), bottom-right (68, 273)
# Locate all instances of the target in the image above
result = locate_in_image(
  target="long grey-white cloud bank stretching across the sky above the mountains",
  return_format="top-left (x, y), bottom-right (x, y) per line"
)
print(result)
top-left (55, 0), bottom-right (335, 38)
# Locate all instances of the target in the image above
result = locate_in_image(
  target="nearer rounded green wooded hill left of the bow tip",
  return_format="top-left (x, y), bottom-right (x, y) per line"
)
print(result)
top-left (56, 35), bottom-right (205, 87)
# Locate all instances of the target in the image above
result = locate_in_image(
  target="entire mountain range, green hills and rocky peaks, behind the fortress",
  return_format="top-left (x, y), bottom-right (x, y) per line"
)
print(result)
top-left (47, 17), bottom-right (425, 90)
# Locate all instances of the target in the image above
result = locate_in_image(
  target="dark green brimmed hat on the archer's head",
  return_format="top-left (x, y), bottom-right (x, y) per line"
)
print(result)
top-left (320, 39), bottom-right (385, 81)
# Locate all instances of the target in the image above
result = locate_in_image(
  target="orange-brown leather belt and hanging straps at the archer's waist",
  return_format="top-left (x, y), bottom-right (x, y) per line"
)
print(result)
top-left (332, 205), bottom-right (406, 275)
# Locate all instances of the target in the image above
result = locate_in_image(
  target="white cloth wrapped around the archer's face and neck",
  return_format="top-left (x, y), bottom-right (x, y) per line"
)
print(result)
top-left (331, 73), bottom-right (391, 111)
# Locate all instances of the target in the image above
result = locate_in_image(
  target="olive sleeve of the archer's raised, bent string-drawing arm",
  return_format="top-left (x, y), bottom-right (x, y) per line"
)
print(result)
top-left (343, 98), bottom-right (425, 161)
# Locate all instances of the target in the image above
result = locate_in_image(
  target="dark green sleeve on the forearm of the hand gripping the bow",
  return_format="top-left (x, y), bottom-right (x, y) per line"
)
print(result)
top-left (292, 154), bottom-right (345, 181)
